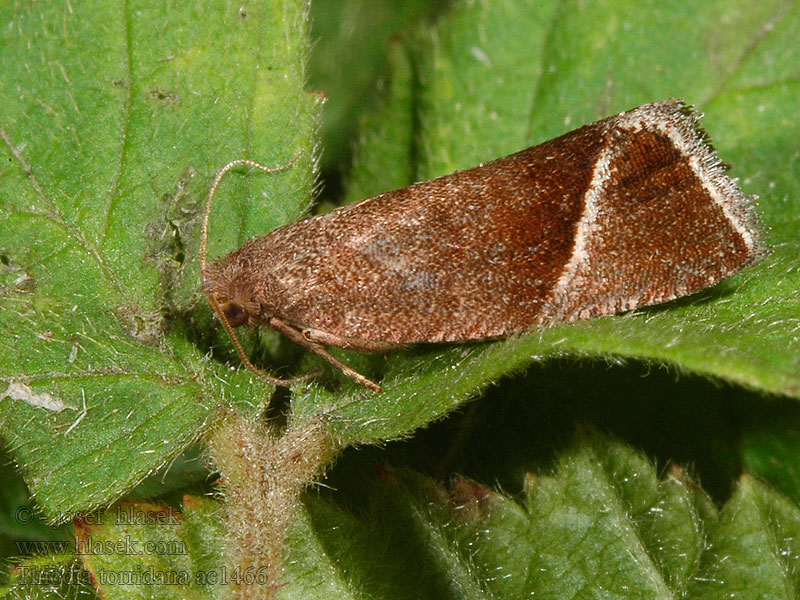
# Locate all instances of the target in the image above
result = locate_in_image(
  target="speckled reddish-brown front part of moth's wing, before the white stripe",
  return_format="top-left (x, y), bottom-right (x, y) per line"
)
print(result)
top-left (268, 126), bottom-right (601, 344)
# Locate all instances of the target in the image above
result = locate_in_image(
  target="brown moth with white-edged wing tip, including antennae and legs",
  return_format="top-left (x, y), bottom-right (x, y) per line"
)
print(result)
top-left (201, 100), bottom-right (764, 390)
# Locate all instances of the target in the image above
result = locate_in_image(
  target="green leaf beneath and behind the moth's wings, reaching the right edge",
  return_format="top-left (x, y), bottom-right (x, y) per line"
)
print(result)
top-left (294, 0), bottom-right (800, 443)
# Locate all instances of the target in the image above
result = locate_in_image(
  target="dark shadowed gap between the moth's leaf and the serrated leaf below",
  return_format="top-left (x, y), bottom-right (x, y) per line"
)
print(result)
top-left (328, 359), bottom-right (800, 503)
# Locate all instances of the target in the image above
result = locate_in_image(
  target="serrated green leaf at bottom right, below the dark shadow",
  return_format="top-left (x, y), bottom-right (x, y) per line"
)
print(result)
top-left (281, 435), bottom-right (800, 599)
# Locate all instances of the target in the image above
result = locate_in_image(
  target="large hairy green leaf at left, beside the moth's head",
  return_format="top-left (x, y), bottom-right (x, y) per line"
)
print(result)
top-left (0, 0), bottom-right (319, 518)
